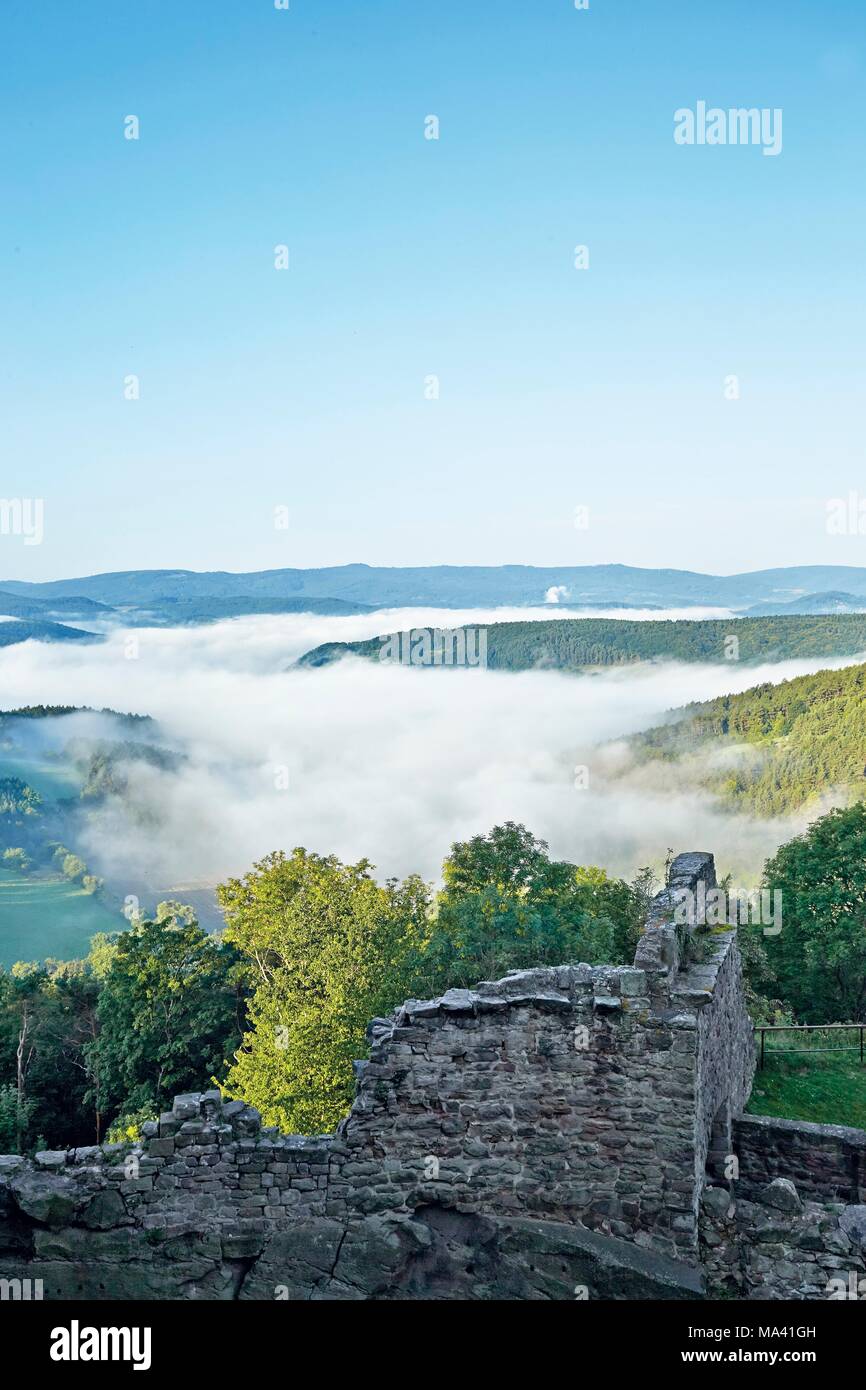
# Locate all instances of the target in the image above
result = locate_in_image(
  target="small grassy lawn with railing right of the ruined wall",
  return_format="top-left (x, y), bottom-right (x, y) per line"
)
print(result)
top-left (746, 1033), bottom-right (866, 1129)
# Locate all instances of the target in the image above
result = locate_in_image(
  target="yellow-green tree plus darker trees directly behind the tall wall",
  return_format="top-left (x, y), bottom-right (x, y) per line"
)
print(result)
top-left (220, 821), bottom-right (651, 1131)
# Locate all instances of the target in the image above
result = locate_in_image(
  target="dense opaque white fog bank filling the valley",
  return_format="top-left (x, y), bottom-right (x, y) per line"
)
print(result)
top-left (0, 609), bottom-right (849, 885)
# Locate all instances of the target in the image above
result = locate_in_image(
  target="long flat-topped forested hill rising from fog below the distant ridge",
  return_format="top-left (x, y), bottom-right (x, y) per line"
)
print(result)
top-left (300, 613), bottom-right (866, 671)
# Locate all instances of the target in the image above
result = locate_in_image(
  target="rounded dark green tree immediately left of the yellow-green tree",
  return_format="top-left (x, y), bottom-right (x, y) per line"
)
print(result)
top-left (86, 904), bottom-right (245, 1115)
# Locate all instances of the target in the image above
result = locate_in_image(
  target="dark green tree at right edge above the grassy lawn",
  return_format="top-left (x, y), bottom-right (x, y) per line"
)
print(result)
top-left (763, 802), bottom-right (866, 1023)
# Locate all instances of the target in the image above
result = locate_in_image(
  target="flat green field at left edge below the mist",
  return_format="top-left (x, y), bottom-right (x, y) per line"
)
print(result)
top-left (0, 869), bottom-right (125, 969)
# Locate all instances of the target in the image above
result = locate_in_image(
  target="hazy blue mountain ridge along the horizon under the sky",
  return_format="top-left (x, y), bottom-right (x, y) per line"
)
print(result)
top-left (8, 564), bottom-right (866, 609)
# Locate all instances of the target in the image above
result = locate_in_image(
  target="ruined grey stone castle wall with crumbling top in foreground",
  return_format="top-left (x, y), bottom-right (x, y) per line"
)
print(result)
top-left (0, 853), bottom-right (866, 1300)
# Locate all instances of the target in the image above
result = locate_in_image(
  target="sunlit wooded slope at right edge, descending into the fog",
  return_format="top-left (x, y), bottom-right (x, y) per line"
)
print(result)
top-left (630, 666), bottom-right (866, 816)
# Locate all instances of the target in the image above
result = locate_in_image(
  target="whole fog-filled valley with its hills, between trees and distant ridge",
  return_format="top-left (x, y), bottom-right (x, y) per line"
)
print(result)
top-left (0, 595), bottom-right (866, 967)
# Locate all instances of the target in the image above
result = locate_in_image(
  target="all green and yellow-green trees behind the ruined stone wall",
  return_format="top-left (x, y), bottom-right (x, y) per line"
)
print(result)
top-left (0, 802), bottom-right (866, 1151)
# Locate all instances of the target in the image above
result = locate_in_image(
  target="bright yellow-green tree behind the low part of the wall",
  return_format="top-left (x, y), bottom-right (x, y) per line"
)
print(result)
top-left (218, 849), bottom-right (430, 1133)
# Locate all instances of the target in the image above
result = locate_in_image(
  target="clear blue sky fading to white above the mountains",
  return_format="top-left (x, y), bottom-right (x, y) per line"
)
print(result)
top-left (0, 0), bottom-right (866, 580)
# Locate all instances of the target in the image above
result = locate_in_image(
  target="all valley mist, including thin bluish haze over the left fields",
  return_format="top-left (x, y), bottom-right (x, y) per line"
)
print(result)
top-left (0, 605), bottom-right (858, 963)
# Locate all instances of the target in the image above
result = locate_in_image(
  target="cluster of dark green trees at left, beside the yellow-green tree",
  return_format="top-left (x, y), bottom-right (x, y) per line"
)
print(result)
top-left (0, 904), bottom-right (245, 1150)
